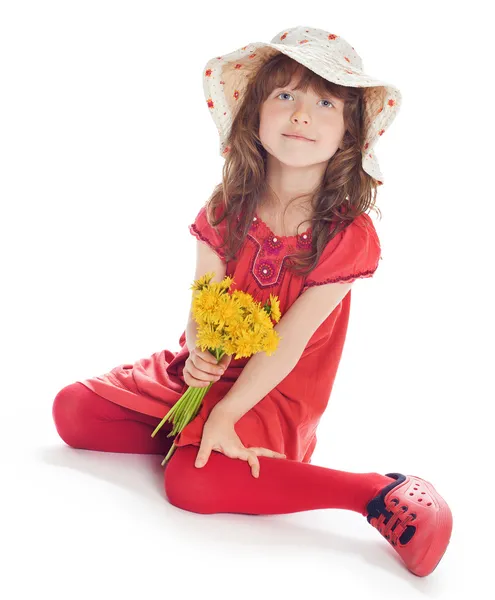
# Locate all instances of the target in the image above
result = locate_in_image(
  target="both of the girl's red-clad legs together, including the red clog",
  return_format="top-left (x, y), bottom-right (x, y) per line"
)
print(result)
top-left (53, 382), bottom-right (452, 576)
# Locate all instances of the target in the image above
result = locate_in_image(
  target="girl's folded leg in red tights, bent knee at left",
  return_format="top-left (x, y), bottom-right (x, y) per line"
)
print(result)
top-left (52, 382), bottom-right (173, 455)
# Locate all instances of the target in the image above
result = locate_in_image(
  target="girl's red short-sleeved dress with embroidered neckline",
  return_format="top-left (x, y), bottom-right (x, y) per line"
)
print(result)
top-left (80, 206), bottom-right (381, 463)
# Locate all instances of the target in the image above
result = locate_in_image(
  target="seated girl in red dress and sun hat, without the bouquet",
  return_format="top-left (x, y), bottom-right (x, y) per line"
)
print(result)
top-left (53, 27), bottom-right (452, 576)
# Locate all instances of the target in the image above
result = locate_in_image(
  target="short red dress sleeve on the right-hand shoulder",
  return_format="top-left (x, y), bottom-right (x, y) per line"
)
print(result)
top-left (304, 213), bottom-right (381, 289)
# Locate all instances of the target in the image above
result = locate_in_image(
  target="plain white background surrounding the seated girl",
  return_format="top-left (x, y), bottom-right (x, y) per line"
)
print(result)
top-left (0, 0), bottom-right (495, 600)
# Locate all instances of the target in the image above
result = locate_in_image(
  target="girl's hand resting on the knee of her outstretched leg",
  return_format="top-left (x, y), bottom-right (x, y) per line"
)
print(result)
top-left (194, 409), bottom-right (286, 477)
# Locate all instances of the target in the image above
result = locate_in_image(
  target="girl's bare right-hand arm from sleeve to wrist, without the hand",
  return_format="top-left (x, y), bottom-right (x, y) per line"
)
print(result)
top-left (213, 283), bottom-right (353, 423)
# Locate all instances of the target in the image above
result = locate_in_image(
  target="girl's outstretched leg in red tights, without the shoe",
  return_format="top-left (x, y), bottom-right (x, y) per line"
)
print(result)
top-left (165, 446), bottom-right (393, 515)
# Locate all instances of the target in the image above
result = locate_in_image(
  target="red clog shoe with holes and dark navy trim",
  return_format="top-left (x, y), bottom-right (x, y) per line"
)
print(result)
top-left (366, 473), bottom-right (452, 577)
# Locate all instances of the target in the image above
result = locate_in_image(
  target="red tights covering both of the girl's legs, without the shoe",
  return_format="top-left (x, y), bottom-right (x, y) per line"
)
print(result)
top-left (52, 382), bottom-right (393, 516)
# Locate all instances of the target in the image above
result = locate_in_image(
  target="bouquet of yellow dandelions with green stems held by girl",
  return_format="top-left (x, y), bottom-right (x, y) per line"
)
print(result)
top-left (151, 272), bottom-right (281, 466)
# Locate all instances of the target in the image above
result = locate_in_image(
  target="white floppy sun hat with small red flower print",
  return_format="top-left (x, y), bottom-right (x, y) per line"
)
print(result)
top-left (203, 26), bottom-right (402, 184)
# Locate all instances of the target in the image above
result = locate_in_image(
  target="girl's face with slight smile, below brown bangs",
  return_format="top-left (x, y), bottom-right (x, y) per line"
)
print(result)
top-left (259, 81), bottom-right (345, 167)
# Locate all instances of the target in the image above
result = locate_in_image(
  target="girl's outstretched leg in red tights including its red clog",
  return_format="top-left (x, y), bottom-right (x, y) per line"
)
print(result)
top-left (165, 445), bottom-right (452, 576)
